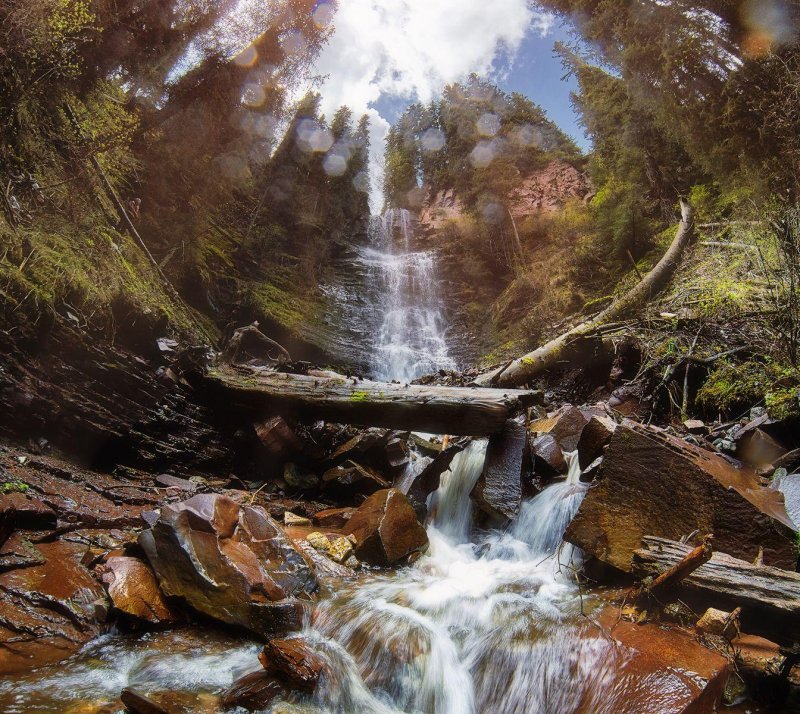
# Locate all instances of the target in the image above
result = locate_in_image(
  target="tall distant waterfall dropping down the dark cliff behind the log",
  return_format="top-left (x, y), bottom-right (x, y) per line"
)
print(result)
top-left (359, 208), bottom-right (455, 381)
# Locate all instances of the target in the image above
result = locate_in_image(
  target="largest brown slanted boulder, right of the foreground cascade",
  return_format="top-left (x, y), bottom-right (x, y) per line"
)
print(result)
top-left (564, 422), bottom-right (797, 572)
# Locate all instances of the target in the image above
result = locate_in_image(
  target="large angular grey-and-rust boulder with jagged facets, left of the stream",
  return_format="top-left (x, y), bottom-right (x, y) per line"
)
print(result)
top-left (139, 494), bottom-right (316, 636)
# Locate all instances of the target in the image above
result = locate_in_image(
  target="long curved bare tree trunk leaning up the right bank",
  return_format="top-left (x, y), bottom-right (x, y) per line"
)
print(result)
top-left (475, 200), bottom-right (694, 387)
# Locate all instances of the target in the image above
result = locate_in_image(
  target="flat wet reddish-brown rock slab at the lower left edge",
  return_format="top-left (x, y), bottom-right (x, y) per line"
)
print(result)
top-left (0, 533), bottom-right (105, 674)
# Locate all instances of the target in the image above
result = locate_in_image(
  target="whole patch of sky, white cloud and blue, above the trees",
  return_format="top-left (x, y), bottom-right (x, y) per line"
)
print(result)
top-left (315, 0), bottom-right (587, 207)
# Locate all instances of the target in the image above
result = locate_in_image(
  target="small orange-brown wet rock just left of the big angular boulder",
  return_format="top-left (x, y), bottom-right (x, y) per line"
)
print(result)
top-left (101, 556), bottom-right (177, 625)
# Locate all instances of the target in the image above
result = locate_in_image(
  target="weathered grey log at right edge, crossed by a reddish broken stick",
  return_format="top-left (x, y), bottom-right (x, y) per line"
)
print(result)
top-left (633, 536), bottom-right (800, 617)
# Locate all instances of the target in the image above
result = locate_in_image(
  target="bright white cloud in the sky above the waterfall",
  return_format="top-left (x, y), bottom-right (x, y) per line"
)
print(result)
top-left (316, 0), bottom-right (553, 211)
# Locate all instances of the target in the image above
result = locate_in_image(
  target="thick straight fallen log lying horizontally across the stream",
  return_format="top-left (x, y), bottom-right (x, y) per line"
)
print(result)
top-left (203, 366), bottom-right (540, 436)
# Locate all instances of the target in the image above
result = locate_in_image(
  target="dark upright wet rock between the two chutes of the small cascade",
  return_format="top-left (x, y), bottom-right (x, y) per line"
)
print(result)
top-left (470, 412), bottom-right (528, 520)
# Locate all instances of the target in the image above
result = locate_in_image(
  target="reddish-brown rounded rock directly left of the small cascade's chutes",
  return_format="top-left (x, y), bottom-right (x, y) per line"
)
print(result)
top-left (344, 488), bottom-right (428, 565)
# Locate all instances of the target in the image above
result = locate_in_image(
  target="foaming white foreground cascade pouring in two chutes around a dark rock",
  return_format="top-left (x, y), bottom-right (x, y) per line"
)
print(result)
top-left (306, 441), bottom-right (615, 714)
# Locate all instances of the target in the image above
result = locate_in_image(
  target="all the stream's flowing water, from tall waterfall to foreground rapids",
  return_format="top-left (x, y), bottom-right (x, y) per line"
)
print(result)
top-left (0, 211), bottom-right (632, 714)
